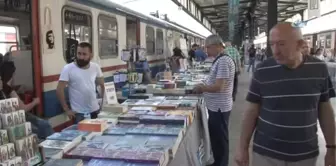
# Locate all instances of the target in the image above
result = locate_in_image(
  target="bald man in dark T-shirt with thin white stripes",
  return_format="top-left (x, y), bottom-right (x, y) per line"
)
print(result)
top-left (235, 22), bottom-right (336, 166)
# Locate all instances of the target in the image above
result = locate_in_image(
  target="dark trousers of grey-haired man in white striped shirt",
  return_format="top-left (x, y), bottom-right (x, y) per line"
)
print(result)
top-left (208, 110), bottom-right (231, 166)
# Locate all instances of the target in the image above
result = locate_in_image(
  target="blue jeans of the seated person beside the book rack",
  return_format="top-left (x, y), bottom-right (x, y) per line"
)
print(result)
top-left (26, 112), bottom-right (54, 139)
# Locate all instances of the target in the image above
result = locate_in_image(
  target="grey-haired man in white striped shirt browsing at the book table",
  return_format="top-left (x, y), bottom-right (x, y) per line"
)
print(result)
top-left (194, 35), bottom-right (236, 166)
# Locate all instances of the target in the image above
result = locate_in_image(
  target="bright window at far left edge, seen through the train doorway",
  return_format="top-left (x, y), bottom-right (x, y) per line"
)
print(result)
top-left (0, 26), bottom-right (18, 55)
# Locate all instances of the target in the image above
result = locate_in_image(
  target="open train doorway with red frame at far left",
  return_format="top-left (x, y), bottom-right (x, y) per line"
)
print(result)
top-left (0, 0), bottom-right (42, 112)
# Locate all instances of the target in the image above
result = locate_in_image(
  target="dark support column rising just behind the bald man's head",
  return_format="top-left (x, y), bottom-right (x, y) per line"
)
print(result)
top-left (266, 0), bottom-right (278, 57)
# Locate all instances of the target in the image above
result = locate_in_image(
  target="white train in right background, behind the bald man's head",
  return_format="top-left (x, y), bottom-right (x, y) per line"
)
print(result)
top-left (254, 11), bottom-right (336, 56)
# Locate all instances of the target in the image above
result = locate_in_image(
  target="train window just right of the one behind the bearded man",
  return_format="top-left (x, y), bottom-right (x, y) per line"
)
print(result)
top-left (98, 15), bottom-right (118, 58)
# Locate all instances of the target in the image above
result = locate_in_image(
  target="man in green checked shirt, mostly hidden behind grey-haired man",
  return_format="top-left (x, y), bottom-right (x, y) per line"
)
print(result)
top-left (225, 42), bottom-right (241, 101)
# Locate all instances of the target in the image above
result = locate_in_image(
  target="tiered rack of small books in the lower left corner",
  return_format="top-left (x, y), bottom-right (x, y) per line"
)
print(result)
top-left (0, 98), bottom-right (42, 166)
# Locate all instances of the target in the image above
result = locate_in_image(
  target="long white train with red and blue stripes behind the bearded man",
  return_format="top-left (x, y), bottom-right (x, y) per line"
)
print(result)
top-left (0, 0), bottom-right (205, 131)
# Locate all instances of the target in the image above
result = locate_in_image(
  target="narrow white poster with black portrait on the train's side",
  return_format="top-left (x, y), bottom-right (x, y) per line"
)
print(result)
top-left (42, 7), bottom-right (55, 54)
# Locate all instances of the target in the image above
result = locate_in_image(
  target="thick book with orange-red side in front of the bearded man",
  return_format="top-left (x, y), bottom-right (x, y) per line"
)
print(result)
top-left (78, 119), bottom-right (108, 132)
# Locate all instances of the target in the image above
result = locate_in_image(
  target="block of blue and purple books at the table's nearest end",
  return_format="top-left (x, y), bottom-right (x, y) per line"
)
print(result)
top-left (66, 135), bottom-right (171, 165)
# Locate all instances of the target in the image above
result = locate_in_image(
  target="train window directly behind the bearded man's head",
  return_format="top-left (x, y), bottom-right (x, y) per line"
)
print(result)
top-left (63, 8), bottom-right (92, 63)
